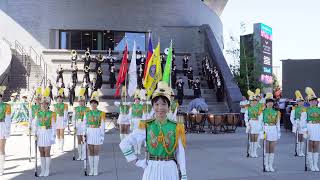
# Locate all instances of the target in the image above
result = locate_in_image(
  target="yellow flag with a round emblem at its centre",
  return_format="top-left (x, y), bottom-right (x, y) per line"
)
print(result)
top-left (143, 42), bottom-right (162, 99)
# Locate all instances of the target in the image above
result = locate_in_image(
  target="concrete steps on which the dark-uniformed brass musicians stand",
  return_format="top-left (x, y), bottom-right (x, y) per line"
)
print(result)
top-left (43, 49), bottom-right (229, 113)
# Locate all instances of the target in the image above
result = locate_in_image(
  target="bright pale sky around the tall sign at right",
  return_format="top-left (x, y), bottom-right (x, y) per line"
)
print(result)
top-left (221, 0), bottom-right (320, 86)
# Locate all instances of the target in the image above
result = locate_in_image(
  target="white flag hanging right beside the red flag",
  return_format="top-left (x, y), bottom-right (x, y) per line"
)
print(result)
top-left (128, 41), bottom-right (137, 96)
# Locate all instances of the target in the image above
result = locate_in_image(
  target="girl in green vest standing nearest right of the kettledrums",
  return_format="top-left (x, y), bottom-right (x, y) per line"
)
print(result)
top-left (244, 90), bottom-right (263, 157)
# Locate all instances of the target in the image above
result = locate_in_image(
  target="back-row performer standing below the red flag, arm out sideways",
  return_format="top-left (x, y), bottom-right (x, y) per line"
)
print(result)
top-left (114, 86), bottom-right (130, 141)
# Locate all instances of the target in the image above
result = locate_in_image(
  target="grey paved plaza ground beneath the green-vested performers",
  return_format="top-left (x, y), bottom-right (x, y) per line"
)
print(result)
top-left (0, 124), bottom-right (320, 180)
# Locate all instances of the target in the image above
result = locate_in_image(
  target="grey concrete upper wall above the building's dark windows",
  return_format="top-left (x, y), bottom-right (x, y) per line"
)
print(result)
top-left (0, 0), bottom-right (223, 52)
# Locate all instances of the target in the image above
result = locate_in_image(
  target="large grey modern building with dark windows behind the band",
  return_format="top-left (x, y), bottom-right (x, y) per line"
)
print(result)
top-left (0, 0), bottom-right (241, 111)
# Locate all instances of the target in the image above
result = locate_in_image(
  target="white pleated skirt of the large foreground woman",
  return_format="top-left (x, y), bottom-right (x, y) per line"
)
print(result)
top-left (142, 160), bottom-right (179, 180)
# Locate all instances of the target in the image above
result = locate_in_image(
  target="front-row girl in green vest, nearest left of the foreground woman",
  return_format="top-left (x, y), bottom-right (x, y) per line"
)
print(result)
top-left (84, 91), bottom-right (106, 176)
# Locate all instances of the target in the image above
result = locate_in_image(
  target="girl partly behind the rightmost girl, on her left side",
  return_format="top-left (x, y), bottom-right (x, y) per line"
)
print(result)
top-left (290, 90), bottom-right (306, 157)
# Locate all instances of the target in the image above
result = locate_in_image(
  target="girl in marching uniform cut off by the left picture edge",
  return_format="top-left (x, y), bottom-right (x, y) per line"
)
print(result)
top-left (0, 86), bottom-right (11, 176)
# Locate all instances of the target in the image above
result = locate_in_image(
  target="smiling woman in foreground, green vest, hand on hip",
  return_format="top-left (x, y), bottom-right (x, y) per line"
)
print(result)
top-left (119, 82), bottom-right (187, 180)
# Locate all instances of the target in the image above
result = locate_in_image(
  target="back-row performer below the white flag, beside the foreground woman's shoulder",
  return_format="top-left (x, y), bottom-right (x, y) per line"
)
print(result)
top-left (129, 89), bottom-right (143, 154)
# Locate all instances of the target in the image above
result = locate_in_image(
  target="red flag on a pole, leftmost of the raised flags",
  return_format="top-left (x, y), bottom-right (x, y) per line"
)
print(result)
top-left (114, 44), bottom-right (128, 97)
